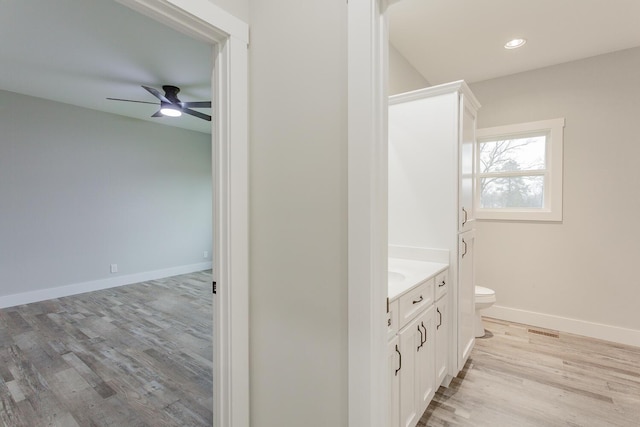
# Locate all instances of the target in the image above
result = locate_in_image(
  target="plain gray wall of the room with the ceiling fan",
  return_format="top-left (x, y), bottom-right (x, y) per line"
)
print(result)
top-left (0, 91), bottom-right (212, 296)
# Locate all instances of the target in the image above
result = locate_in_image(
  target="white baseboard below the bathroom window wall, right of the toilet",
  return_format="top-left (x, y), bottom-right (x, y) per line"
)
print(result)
top-left (482, 305), bottom-right (640, 347)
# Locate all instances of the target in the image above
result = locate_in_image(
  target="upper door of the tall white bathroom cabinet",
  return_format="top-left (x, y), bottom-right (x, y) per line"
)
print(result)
top-left (458, 95), bottom-right (476, 232)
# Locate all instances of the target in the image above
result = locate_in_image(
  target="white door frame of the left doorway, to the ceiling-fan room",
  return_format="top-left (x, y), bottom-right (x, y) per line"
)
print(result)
top-left (116, 0), bottom-right (249, 427)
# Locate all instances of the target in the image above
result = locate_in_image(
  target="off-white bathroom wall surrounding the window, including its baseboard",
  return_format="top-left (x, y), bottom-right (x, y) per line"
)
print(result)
top-left (471, 48), bottom-right (640, 345)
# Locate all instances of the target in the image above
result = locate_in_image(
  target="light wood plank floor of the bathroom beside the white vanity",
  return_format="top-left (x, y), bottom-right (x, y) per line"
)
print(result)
top-left (418, 318), bottom-right (640, 427)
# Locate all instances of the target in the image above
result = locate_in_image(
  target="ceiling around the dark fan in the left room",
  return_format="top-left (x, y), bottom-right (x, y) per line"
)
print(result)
top-left (0, 0), bottom-right (213, 133)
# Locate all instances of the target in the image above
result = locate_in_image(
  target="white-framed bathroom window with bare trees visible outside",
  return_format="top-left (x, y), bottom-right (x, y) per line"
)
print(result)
top-left (475, 119), bottom-right (564, 221)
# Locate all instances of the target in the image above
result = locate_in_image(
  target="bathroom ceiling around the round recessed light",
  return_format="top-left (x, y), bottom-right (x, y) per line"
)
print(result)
top-left (389, 0), bottom-right (640, 85)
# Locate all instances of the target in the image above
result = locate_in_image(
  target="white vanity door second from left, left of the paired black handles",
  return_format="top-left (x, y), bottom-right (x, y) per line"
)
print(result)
top-left (398, 316), bottom-right (424, 427)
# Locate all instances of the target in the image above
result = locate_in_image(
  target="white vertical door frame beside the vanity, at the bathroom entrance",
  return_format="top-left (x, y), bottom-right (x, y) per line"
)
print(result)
top-left (348, 0), bottom-right (390, 427)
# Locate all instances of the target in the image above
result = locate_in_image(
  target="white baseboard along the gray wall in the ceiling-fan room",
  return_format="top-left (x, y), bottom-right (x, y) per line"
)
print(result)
top-left (0, 261), bottom-right (212, 308)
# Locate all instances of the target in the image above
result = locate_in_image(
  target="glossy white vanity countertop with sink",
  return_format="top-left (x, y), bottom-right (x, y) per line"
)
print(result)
top-left (388, 258), bottom-right (449, 301)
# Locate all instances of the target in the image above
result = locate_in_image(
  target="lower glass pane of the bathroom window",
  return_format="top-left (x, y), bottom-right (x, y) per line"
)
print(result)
top-left (480, 176), bottom-right (544, 209)
